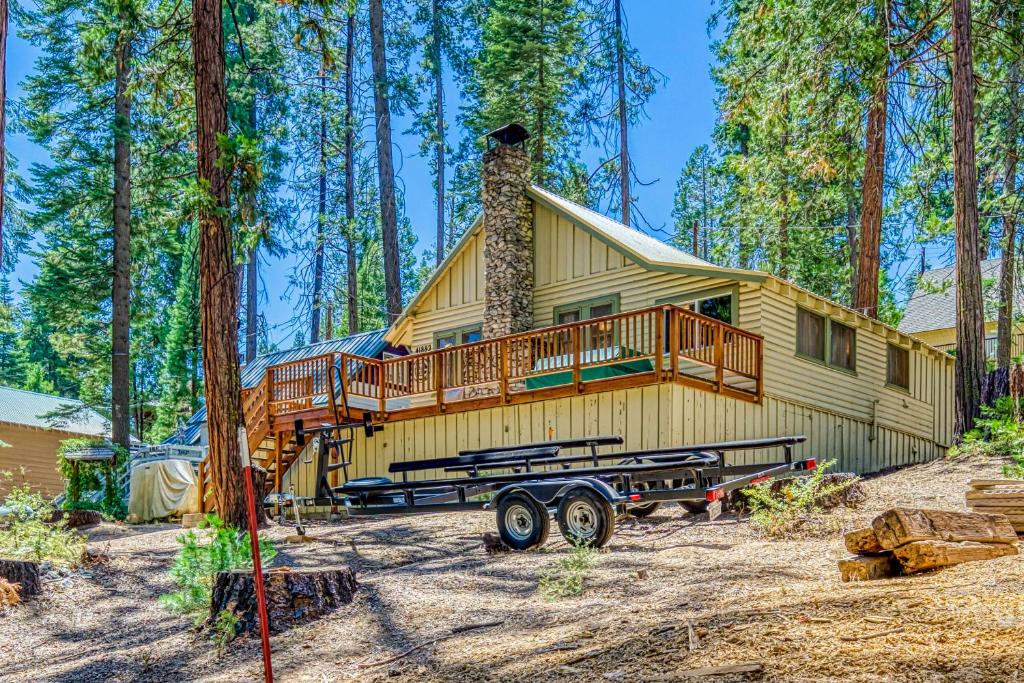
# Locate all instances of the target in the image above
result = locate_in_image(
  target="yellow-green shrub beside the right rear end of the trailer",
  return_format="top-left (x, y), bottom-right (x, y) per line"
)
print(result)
top-left (741, 460), bottom-right (857, 538)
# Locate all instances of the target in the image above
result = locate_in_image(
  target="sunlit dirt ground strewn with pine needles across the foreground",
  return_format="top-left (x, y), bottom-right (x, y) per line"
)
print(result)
top-left (0, 454), bottom-right (1024, 683)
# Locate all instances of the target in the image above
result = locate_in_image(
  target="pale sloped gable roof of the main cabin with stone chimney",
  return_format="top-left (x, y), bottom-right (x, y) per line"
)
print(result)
top-left (387, 185), bottom-right (768, 338)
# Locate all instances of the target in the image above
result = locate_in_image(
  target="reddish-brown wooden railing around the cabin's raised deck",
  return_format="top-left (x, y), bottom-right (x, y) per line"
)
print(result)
top-left (243, 305), bottom-right (763, 425)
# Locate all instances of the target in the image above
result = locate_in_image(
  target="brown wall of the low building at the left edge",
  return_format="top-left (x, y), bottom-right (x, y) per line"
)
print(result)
top-left (0, 423), bottom-right (75, 499)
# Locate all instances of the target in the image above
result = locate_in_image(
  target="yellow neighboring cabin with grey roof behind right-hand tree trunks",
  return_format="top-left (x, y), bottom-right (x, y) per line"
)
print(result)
top-left (899, 258), bottom-right (1024, 360)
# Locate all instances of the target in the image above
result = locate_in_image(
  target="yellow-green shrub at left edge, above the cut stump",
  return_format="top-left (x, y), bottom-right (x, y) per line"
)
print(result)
top-left (0, 472), bottom-right (85, 566)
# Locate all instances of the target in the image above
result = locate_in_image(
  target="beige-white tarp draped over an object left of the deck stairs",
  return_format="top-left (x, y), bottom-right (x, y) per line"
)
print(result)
top-left (128, 460), bottom-right (199, 522)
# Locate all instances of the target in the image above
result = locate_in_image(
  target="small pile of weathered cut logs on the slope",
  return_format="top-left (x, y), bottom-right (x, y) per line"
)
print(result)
top-left (839, 508), bottom-right (1018, 582)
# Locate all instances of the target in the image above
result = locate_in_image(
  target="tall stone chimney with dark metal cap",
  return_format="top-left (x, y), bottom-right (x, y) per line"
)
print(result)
top-left (483, 124), bottom-right (534, 338)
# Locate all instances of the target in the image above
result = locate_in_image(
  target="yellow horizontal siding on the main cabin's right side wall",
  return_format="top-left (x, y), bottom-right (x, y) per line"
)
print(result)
top-left (761, 288), bottom-right (952, 445)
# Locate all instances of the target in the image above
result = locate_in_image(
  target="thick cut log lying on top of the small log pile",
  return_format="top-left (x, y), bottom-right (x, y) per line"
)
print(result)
top-left (871, 508), bottom-right (1017, 550)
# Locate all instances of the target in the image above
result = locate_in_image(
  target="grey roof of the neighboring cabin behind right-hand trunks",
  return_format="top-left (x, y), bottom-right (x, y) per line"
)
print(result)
top-left (899, 258), bottom-right (1024, 334)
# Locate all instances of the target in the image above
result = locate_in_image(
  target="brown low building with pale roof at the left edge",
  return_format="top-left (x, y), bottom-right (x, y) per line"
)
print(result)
top-left (0, 386), bottom-right (110, 498)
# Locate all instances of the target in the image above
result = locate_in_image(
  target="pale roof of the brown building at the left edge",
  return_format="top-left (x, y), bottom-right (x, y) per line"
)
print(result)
top-left (0, 386), bottom-right (111, 436)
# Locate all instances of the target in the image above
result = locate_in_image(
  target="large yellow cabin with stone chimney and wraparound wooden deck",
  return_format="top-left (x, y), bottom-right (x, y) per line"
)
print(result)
top-left (193, 126), bottom-right (953, 507)
